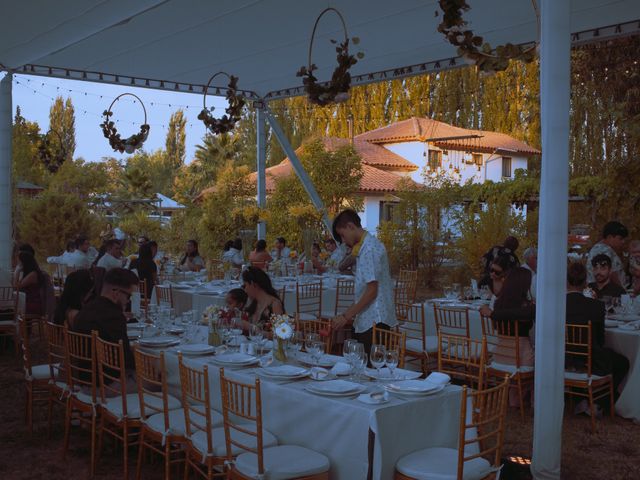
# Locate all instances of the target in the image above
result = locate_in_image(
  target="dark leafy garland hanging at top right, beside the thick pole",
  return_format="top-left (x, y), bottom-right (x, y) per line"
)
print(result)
top-left (436, 0), bottom-right (537, 74)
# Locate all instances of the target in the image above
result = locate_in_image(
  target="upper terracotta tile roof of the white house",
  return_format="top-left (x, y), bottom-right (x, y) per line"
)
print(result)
top-left (356, 117), bottom-right (540, 156)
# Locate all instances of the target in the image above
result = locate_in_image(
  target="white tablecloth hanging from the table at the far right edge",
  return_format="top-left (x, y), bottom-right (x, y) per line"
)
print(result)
top-left (605, 328), bottom-right (640, 422)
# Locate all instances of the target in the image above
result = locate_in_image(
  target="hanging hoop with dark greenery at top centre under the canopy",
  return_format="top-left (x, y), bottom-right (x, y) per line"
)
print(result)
top-left (296, 7), bottom-right (364, 105)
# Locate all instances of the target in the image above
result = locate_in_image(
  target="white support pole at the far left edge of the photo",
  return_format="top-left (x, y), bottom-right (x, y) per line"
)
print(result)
top-left (0, 72), bottom-right (13, 271)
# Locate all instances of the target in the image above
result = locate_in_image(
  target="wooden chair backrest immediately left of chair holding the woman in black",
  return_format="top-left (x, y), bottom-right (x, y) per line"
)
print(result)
top-left (438, 332), bottom-right (487, 390)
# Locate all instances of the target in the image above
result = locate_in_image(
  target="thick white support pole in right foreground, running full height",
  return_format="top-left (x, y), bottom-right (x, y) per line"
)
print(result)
top-left (531, 0), bottom-right (571, 480)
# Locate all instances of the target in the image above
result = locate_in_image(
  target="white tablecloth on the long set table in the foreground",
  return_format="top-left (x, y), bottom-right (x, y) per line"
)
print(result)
top-left (166, 354), bottom-right (461, 480)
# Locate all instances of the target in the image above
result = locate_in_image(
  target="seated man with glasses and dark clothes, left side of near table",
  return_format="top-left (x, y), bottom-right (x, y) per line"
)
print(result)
top-left (74, 268), bottom-right (138, 393)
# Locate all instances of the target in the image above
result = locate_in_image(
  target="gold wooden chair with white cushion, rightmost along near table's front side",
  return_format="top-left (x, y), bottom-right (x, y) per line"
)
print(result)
top-left (220, 368), bottom-right (330, 480)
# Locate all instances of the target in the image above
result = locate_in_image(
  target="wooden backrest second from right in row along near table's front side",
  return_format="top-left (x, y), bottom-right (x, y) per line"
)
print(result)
top-left (178, 354), bottom-right (213, 454)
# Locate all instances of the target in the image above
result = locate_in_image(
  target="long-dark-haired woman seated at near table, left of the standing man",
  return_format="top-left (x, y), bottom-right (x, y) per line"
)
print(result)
top-left (242, 267), bottom-right (284, 325)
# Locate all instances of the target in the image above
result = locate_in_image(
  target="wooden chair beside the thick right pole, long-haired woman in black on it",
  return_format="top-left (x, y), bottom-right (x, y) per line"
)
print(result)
top-left (481, 317), bottom-right (534, 421)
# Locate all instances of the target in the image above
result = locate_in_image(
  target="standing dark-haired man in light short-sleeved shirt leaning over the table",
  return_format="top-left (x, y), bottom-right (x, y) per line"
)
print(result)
top-left (332, 210), bottom-right (398, 354)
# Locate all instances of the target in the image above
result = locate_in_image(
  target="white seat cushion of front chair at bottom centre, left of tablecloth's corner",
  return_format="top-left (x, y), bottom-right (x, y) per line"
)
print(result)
top-left (236, 445), bottom-right (331, 480)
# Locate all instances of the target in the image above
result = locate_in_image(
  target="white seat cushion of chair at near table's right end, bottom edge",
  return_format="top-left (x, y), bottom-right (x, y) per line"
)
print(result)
top-left (396, 447), bottom-right (492, 480)
